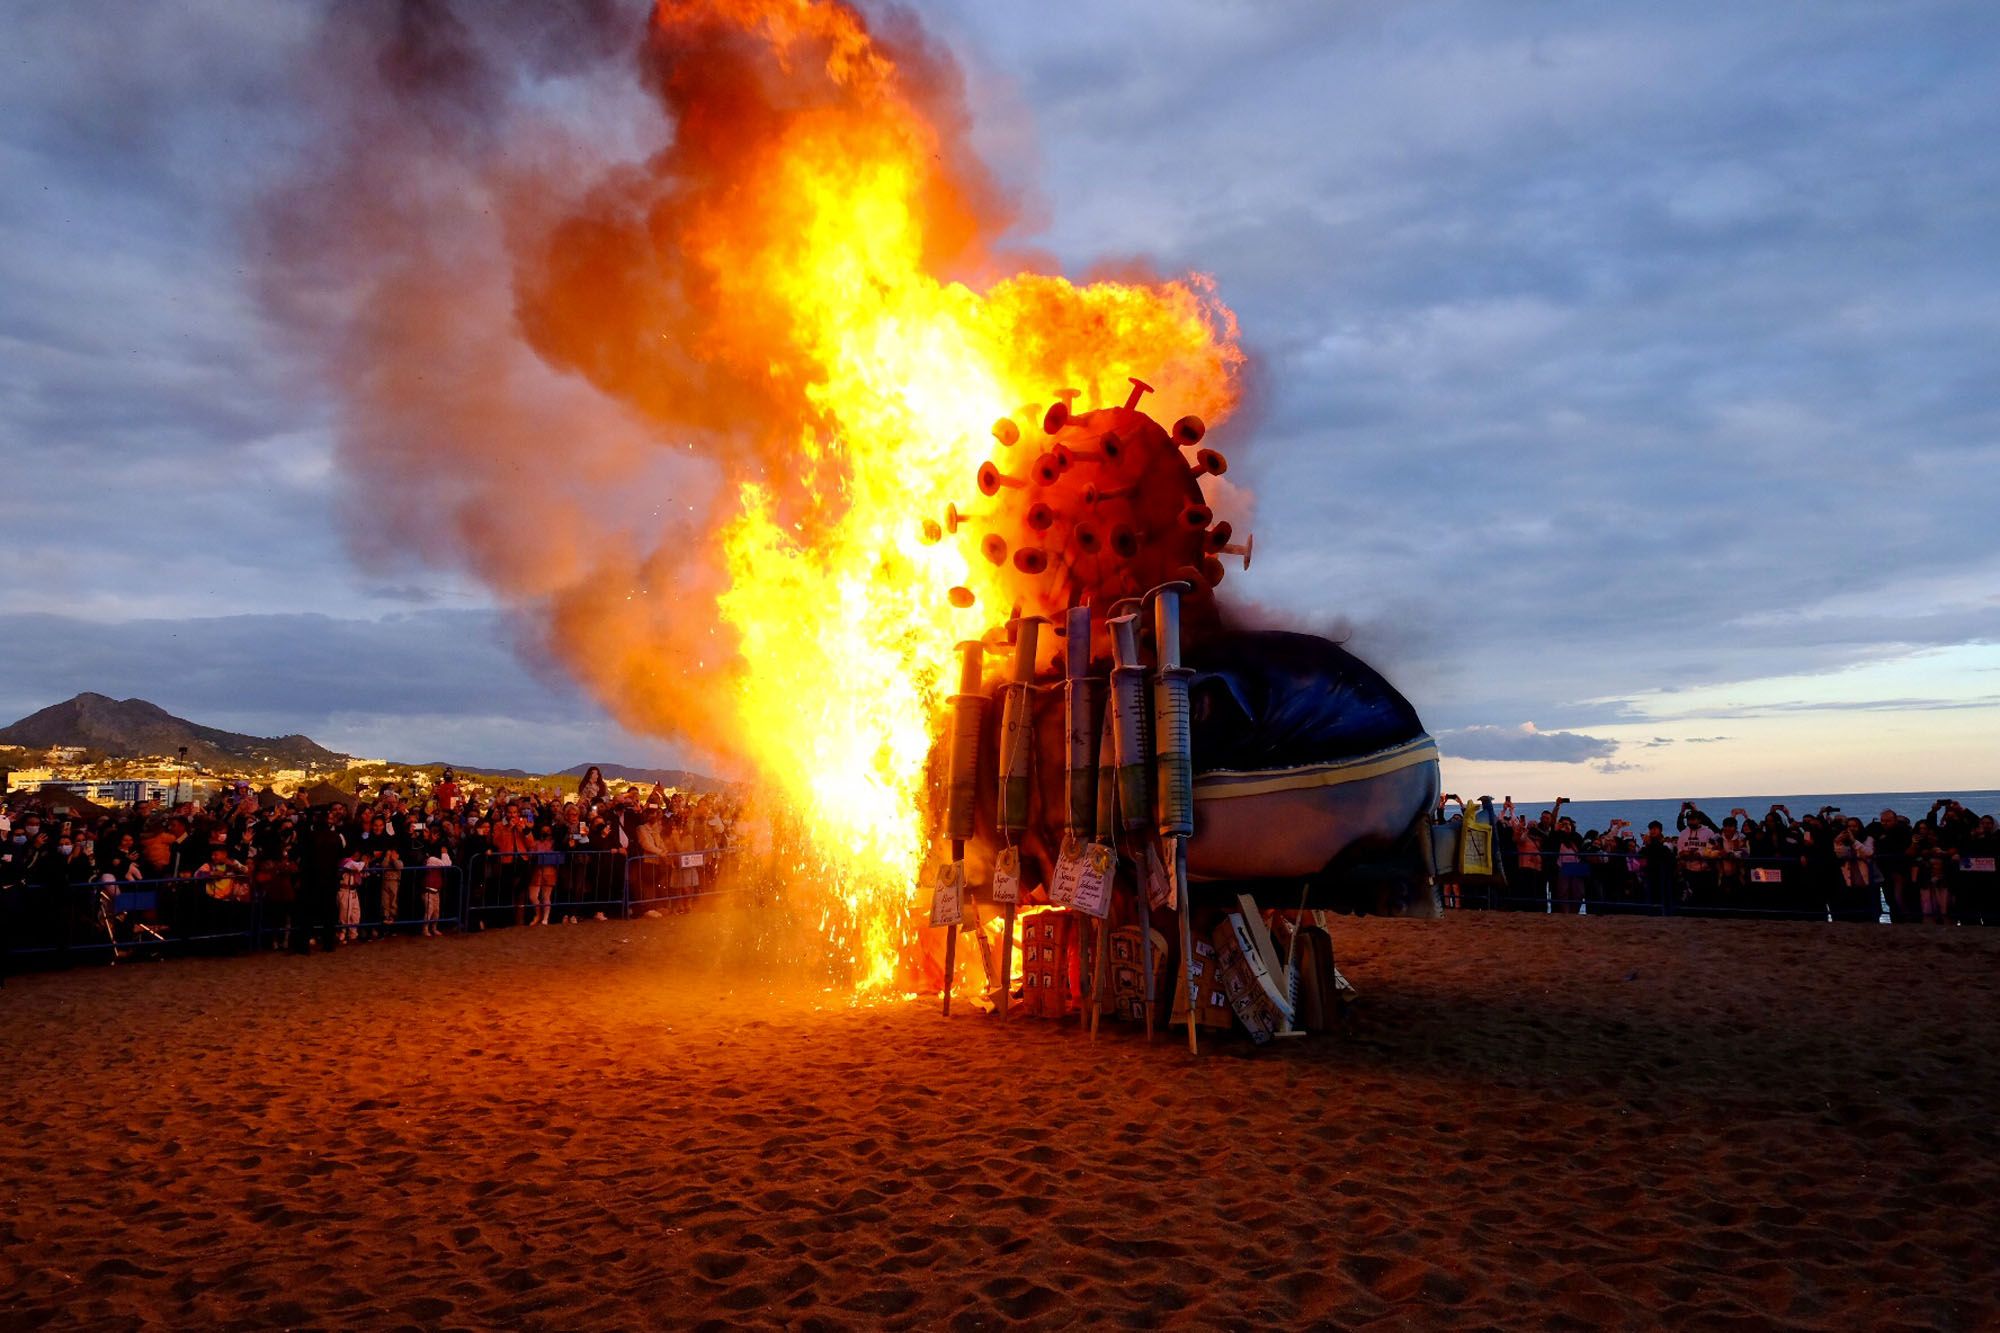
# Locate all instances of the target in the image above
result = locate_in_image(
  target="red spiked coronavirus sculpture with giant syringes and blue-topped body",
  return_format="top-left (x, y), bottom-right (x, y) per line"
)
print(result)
top-left (924, 378), bottom-right (1438, 1047)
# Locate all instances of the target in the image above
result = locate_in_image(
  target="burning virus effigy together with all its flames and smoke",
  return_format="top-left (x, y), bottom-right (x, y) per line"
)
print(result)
top-left (258, 0), bottom-right (1436, 1023)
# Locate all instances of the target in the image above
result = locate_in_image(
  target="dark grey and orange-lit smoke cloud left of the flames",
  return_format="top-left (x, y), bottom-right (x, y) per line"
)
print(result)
top-left (258, 0), bottom-right (1048, 751)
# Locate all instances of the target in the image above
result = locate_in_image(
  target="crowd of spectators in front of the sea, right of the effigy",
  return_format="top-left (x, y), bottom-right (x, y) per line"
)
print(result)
top-left (1456, 799), bottom-right (2000, 925)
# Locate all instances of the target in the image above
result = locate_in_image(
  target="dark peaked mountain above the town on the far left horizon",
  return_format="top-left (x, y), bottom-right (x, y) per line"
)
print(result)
top-left (0, 693), bottom-right (350, 769)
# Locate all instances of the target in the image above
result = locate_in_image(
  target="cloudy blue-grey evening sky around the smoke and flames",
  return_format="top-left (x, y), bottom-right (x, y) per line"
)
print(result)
top-left (0, 0), bottom-right (2000, 799)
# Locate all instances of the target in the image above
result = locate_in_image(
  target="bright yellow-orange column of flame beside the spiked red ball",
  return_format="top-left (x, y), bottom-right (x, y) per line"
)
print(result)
top-left (656, 2), bottom-right (1240, 976)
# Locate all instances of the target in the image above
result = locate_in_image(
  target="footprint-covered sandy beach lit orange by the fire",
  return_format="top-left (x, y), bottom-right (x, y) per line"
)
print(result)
top-left (0, 915), bottom-right (2000, 1329)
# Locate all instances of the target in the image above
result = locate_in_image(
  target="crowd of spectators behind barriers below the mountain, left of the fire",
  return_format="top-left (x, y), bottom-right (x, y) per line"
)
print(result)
top-left (0, 769), bottom-right (742, 953)
